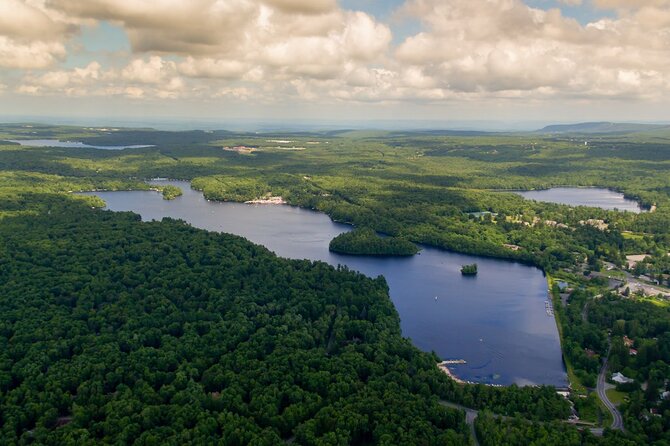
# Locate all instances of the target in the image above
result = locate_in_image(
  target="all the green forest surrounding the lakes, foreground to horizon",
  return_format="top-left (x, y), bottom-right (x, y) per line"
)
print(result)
top-left (0, 125), bottom-right (670, 446)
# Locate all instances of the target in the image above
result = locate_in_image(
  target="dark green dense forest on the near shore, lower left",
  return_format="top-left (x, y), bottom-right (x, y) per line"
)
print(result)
top-left (0, 194), bottom-right (568, 445)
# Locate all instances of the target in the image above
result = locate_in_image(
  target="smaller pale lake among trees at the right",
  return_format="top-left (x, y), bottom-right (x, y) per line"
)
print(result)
top-left (515, 187), bottom-right (642, 213)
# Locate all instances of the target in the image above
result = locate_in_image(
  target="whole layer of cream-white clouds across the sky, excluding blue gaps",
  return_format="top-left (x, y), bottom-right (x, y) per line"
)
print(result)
top-left (0, 0), bottom-right (670, 102)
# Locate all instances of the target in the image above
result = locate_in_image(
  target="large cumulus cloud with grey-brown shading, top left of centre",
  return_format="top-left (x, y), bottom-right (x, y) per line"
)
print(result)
top-left (36, 0), bottom-right (391, 84)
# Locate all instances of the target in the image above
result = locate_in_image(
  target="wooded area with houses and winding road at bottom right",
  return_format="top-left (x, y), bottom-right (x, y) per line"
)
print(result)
top-left (554, 276), bottom-right (670, 445)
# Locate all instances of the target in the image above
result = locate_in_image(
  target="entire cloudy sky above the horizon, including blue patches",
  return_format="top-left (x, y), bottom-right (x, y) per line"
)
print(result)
top-left (0, 0), bottom-right (670, 127)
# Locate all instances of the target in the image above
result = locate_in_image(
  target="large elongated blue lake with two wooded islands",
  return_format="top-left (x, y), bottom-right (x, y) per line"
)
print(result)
top-left (81, 181), bottom-right (567, 387)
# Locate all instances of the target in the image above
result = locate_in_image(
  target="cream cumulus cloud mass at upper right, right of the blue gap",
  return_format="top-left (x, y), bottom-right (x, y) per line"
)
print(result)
top-left (396, 0), bottom-right (670, 96)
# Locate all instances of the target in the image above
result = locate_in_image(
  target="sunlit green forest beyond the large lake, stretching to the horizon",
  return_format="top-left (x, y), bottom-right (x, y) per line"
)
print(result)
top-left (0, 120), bottom-right (670, 270)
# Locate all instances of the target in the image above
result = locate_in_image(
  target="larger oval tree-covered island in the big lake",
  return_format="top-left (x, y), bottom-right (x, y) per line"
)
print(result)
top-left (329, 228), bottom-right (419, 256)
